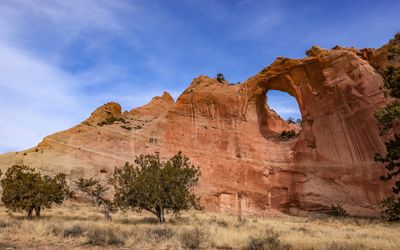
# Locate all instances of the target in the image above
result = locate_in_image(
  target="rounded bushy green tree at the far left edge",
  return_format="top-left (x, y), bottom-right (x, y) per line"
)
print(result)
top-left (0, 165), bottom-right (73, 218)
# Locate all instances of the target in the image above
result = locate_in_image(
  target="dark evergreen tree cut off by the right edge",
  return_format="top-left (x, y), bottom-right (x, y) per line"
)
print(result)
top-left (374, 54), bottom-right (400, 220)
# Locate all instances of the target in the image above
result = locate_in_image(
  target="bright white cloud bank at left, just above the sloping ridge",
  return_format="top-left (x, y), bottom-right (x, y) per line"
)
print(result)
top-left (0, 36), bottom-right (177, 153)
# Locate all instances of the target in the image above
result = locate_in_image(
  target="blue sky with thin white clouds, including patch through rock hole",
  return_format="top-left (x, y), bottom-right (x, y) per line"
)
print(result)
top-left (0, 0), bottom-right (400, 152)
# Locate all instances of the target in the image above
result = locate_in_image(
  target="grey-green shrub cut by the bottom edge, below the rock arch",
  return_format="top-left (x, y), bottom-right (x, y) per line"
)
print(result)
top-left (245, 231), bottom-right (291, 250)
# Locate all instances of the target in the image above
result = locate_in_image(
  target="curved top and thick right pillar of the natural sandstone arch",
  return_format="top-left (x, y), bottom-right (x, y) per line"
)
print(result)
top-left (241, 50), bottom-right (387, 213)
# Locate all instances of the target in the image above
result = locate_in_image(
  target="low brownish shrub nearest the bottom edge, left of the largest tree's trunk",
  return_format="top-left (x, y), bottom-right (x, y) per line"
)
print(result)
top-left (86, 227), bottom-right (125, 245)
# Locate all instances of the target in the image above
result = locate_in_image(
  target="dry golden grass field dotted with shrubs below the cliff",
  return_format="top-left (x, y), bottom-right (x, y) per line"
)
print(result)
top-left (0, 202), bottom-right (400, 250)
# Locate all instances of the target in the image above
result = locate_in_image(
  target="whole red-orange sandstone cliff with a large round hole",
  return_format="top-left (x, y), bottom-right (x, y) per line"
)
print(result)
top-left (0, 35), bottom-right (398, 215)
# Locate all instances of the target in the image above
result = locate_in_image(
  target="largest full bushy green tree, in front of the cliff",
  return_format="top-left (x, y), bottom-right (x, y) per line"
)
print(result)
top-left (114, 152), bottom-right (200, 223)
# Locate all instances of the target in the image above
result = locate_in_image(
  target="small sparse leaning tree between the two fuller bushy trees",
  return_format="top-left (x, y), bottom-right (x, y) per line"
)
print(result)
top-left (75, 178), bottom-right (117, 220)
